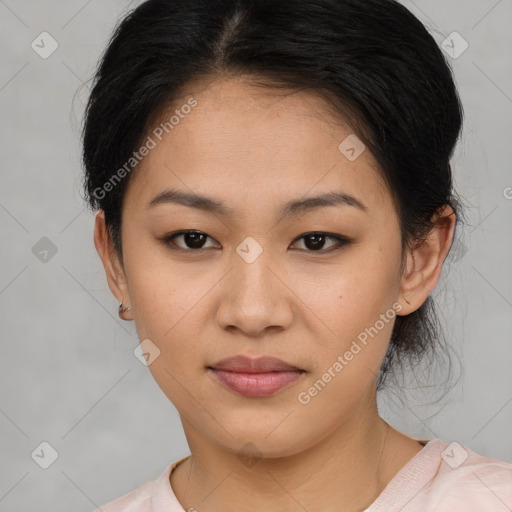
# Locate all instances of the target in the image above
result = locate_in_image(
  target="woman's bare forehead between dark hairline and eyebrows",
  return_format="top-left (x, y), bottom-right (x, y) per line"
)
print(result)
top-left (123, 74), bottom-right (389, 214)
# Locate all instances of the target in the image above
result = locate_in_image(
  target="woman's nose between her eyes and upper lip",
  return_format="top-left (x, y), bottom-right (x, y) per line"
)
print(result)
top-left (216, 246), bottom-right (293, 337)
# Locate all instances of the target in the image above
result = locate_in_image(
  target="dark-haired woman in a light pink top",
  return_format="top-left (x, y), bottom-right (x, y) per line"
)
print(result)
top-left (83, 0), bottom-right (512, 512)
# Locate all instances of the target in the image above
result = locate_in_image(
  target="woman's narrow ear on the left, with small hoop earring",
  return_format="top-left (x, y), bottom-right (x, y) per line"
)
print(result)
top-left (94, 210), bottom-right (132, 320)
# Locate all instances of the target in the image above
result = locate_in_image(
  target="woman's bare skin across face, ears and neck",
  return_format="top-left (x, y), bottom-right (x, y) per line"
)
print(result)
top-left (94, 74), bottom-right (455, 512)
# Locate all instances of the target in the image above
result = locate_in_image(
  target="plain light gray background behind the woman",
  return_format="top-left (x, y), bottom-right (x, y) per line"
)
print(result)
top-left (0, 0), bottom-right (512, 512)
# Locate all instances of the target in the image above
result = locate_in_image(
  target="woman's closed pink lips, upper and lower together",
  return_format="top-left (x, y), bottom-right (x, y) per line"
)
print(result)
top-left (209, 356), bottom-right (305, 397)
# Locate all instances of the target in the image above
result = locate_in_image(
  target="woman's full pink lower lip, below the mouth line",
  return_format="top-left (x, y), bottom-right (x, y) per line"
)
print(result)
top-left (210, 368), bottom-right (305, 397)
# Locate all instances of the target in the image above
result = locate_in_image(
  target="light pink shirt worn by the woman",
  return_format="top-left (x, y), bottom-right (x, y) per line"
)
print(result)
top-left (94, 438), bottom-right (512, 512)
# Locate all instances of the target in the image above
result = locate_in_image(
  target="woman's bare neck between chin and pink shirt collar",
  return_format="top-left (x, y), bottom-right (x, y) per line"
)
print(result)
top-left (171, 405), bottom-right (421, 512)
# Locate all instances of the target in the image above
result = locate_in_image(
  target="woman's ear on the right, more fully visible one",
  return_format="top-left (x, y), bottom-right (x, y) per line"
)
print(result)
top-left (399, 205), bottom-right (456, 316)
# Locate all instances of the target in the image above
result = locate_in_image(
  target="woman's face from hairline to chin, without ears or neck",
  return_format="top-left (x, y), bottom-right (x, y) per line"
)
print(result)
top-left (106, 79), bottom-right (410, 457)
